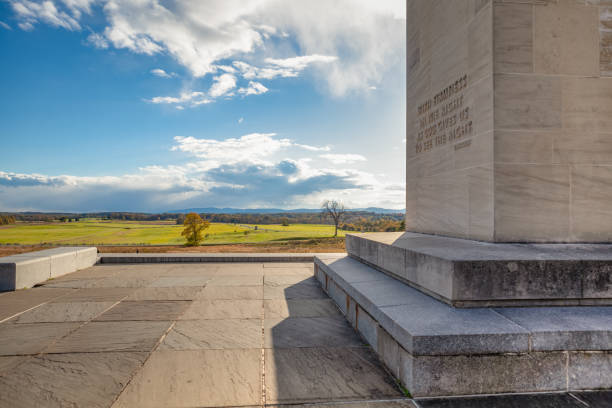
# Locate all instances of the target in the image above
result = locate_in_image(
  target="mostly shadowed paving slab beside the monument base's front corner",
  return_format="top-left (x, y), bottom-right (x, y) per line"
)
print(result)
top-left (265, 348), bottom-right (402, 404)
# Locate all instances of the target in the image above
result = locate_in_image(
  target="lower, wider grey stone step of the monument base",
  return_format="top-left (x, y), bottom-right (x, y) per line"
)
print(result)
top-left (315, 256), bottom-right (612, 397)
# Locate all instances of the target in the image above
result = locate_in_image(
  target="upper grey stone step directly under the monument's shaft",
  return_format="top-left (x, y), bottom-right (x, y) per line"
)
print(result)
top-left (346, 232), bottom-right (612, 307)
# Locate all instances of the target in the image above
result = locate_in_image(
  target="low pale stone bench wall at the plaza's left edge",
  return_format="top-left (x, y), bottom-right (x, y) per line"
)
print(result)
top-left (0, 247), bottom-right (98, 291)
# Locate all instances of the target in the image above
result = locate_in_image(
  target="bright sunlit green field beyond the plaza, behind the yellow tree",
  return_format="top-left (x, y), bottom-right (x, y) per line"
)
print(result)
top-left (0, 220), bottom-right (344, 245)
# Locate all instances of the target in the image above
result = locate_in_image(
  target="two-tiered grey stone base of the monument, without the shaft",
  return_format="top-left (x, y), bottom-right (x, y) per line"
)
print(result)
top-left (315, 233), bottom-right (612, 397)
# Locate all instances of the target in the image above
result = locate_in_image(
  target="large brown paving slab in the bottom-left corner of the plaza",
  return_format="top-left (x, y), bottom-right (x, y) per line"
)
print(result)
top-left (0, 353), bottom-right (147, 408)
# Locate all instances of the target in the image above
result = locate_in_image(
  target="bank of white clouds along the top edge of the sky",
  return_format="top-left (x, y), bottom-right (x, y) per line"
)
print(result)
top-left (9, 0), bottom-right (406, 96)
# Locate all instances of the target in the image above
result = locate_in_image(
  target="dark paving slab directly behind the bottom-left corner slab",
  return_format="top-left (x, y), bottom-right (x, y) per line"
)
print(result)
top-left (47, 321), bottom-right (172, 353)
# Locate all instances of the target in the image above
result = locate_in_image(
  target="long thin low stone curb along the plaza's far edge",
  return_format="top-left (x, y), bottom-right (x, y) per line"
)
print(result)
top-left (100, 253), bottom-right (345, 264)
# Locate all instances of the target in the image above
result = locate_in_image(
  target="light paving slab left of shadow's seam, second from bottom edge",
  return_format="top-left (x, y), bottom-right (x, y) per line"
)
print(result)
top-left (159, 319), bottom-right (263, 350)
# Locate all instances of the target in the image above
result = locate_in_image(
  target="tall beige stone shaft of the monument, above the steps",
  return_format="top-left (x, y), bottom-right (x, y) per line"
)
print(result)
top-left (406, 0), bottom-right (612, 242)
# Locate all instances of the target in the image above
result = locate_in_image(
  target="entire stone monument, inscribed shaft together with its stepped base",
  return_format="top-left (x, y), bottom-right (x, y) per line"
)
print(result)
top-left (315, 0), bottom-right (612, 397)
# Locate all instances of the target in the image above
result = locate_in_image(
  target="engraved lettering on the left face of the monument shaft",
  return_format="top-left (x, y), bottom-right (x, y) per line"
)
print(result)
top-left (416, 75), bottom-right (473, 154)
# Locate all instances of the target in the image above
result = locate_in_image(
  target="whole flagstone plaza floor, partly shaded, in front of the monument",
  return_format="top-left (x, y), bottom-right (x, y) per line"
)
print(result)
top-left (0, 263), bottom-right (610, 408)
